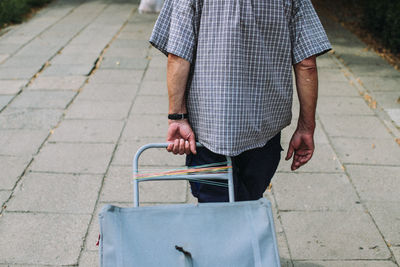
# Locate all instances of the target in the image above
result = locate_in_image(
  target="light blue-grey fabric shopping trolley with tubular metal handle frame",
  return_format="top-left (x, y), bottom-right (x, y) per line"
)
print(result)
top-left (99, 144), bottom-right (280, 267)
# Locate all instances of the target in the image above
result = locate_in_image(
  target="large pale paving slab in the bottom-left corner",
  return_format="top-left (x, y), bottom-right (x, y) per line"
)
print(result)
top-left (0, 212), bottom-right (90, 266)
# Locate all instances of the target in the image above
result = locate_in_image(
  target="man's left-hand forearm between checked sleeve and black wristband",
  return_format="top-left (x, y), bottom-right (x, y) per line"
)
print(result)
top-left (167, 54), bottom-right (190, 114)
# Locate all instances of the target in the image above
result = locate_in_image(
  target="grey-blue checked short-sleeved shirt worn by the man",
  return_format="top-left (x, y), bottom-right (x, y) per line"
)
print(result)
top-left (150, 0), bottom-right (331, 156)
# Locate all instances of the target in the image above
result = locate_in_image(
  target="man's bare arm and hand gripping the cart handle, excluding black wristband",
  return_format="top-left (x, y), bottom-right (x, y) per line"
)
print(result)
top-left (167, 54), bottom-right (196, 155)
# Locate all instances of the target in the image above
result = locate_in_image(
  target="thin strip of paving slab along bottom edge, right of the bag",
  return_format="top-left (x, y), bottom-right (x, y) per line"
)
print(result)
top-left (294, 260), bottom-right (397, 267)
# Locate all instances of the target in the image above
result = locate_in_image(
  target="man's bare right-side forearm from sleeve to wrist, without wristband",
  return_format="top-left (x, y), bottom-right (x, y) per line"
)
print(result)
top-left (294, 56), bottom-right (318, 133)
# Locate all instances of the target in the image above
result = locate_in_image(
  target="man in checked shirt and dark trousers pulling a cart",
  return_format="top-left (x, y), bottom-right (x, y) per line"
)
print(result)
top-left (150, 0), bottom-right (331, 202)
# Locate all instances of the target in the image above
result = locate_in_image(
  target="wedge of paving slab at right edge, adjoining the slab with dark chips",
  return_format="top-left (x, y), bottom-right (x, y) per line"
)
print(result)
top-left (366, 201), bottom-right (400, 246)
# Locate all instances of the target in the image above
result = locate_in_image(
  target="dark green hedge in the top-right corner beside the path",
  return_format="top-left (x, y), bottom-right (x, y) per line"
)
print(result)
top-left (360, 0), bottom-right (400, 52)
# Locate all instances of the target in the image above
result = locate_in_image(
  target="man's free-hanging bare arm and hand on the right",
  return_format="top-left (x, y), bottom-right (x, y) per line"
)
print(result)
top-left (286, 56), bottom-right (318, 170)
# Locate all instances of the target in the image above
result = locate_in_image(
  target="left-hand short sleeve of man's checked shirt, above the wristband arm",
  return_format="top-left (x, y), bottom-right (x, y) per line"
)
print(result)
top-left (150, 0), bottom-right (196, 63)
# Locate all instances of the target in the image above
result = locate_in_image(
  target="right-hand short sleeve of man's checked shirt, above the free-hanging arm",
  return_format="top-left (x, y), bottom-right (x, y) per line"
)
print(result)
top-left (290, 0), bottom-right (332, 64)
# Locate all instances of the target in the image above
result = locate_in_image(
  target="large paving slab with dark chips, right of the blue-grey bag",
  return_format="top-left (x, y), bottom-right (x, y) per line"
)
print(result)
top-left (280, 211), bottom-right (390, 260)
